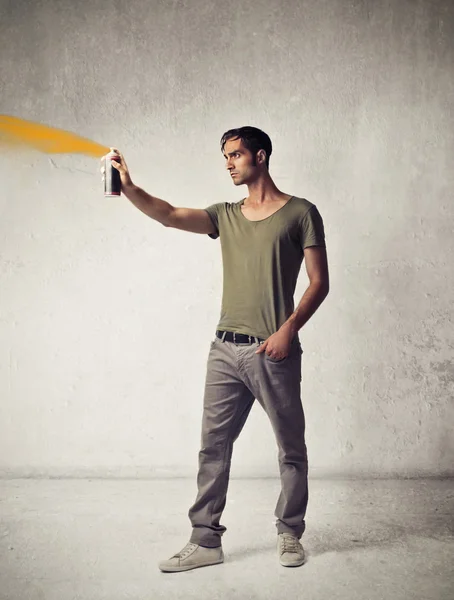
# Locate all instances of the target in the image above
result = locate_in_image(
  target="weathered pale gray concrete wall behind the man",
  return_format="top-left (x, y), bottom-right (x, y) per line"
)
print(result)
top-left (0, 0), bottom-right (454, 477)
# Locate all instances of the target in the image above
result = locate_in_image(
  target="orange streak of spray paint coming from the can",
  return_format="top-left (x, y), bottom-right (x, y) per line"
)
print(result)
top-left (0, 115), bottom-right (110, 158)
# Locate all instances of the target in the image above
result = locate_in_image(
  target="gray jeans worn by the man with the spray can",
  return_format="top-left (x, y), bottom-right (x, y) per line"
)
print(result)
top-left (189, 336), bottom-right (308, 547)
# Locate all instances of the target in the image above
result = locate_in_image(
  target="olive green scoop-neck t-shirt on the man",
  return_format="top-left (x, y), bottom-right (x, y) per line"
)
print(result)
top-left (205, 196), bottom-right (325, 339)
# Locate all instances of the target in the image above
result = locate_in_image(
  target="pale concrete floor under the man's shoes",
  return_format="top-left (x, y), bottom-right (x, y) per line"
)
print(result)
top-left (0, 479), bottom-right (454, 600)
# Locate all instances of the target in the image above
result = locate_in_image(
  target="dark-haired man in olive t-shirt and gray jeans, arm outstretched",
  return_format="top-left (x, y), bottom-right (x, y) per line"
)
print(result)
top-left (101, 127), bottom-right (329, 572)
